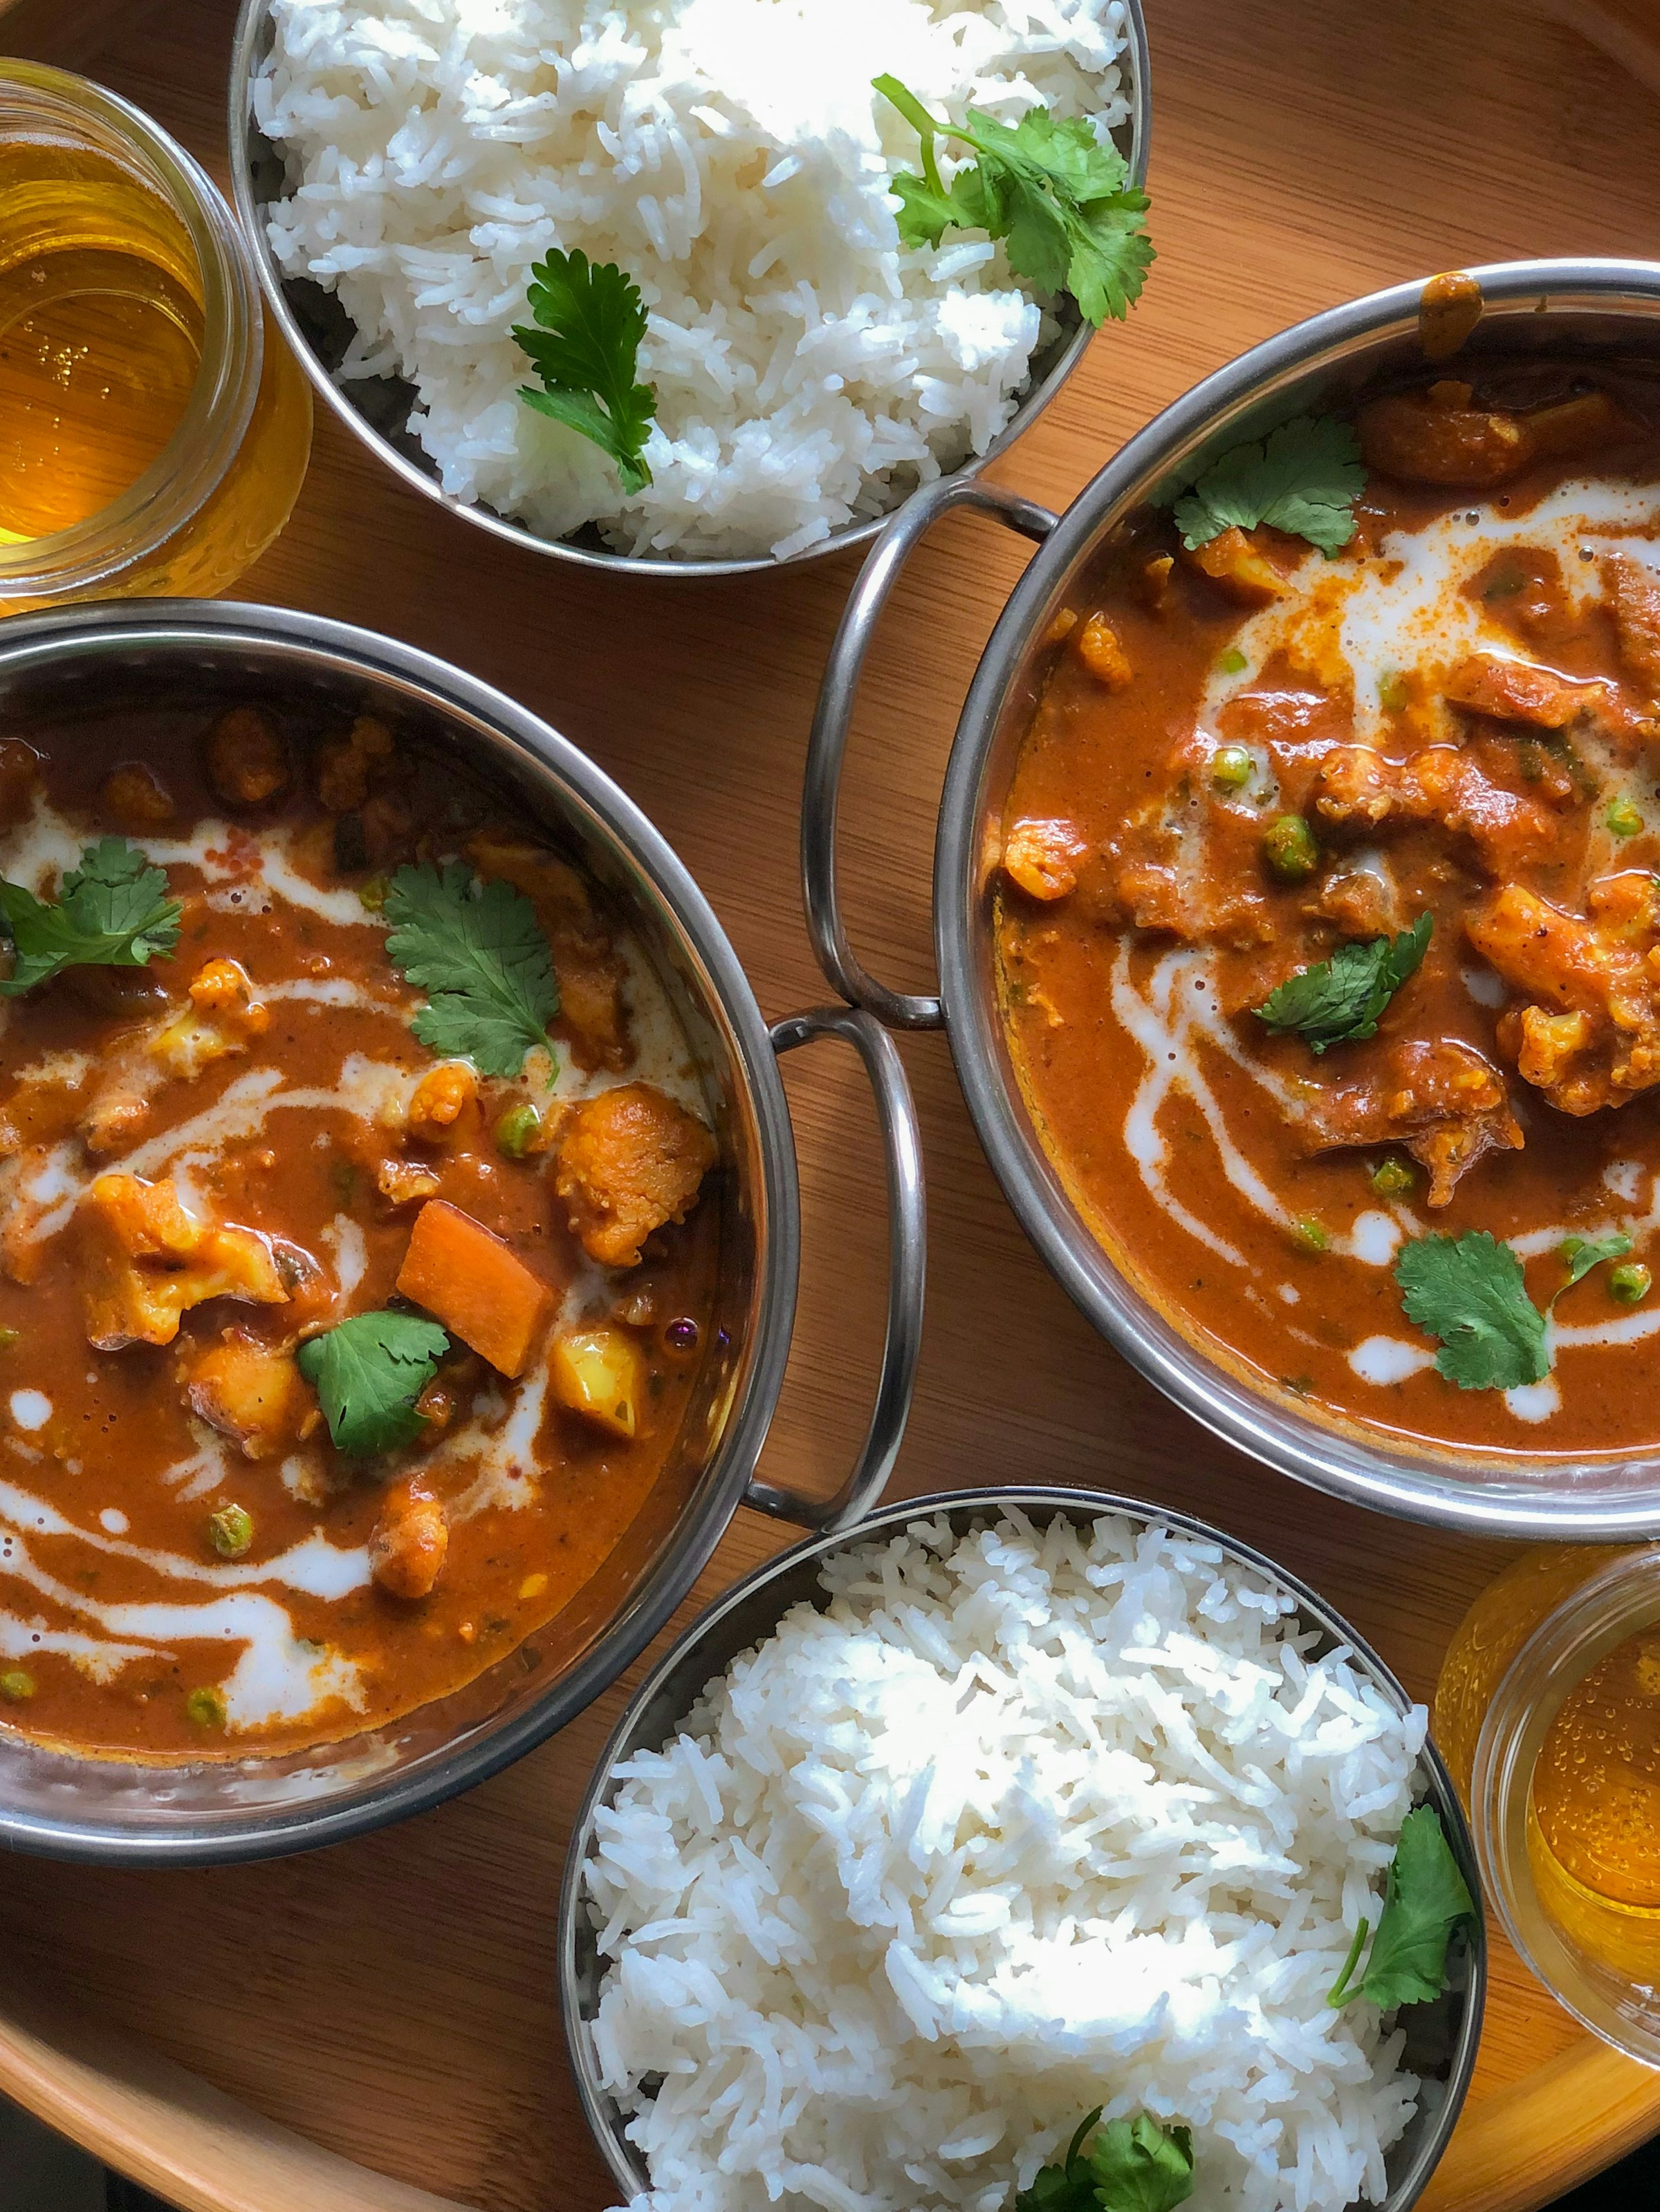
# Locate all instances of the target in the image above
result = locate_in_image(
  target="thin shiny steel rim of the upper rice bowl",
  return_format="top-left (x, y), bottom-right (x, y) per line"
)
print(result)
top-left (228, 0), bottom-right (1153, 579)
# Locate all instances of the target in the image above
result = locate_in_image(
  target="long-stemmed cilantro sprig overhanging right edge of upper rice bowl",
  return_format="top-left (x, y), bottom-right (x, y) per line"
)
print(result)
top-left (870, 75), bottom-right (1153, 327)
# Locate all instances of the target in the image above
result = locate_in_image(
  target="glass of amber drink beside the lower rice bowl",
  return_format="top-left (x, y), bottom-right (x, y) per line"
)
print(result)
top-left (1435, 1544), bottom-right (1660, 2066)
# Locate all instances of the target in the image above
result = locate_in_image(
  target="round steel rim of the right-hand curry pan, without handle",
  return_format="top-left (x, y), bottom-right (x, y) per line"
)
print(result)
top-left (938, 257), bottom-right (1660, 1542)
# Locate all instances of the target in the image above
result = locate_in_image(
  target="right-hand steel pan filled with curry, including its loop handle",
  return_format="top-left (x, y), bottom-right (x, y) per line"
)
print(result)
top-left (804, 261), bottom-right (1660, 1537)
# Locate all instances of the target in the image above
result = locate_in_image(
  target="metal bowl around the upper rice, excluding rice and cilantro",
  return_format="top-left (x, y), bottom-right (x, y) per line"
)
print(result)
top-left (230, 0), bottom-right (1151, 577)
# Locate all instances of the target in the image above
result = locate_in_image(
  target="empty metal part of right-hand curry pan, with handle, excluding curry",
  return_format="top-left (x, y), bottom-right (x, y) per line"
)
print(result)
top-left (801, 261), bottom-right (1660, 1540)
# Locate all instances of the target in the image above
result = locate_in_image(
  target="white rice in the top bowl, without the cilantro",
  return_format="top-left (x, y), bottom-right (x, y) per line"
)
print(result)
top-left (255, 0), bottom-right (1127, 557)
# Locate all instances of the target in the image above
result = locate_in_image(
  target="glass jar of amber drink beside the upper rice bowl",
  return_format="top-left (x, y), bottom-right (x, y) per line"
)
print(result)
top-left (0, 59), bottom-right (312, 615)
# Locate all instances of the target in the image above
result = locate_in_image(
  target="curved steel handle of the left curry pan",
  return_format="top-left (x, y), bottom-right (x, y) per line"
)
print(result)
top-left (744, 1007), bottom-right (928, 1535)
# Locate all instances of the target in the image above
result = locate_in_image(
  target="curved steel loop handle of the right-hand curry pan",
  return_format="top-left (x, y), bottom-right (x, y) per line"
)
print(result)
top-left (801, 476), bottom-right (1058, 1029)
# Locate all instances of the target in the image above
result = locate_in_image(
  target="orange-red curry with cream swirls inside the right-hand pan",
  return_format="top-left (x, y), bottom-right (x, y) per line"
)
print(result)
top-left (996, 360), bottom-right (1660, 1456)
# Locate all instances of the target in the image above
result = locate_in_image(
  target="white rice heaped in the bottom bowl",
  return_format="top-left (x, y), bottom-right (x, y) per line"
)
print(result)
top-left (587, 1518), bottom-right (1435, 2212)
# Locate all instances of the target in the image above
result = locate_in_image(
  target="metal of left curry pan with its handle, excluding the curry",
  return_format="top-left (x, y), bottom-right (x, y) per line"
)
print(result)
top-left (0, 600), bottom-right (925, 1865)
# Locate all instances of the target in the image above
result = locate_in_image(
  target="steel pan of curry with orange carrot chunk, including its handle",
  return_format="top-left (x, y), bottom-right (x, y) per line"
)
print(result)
top-left (0, 602), bottom-right (923, 1860)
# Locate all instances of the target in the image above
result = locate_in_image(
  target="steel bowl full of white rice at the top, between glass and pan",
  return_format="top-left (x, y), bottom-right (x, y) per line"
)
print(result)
top-left (230, 0), bottom-right (1149, 577)
